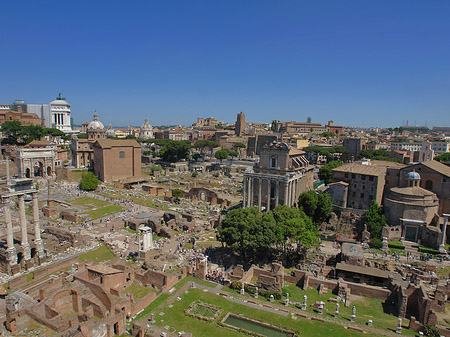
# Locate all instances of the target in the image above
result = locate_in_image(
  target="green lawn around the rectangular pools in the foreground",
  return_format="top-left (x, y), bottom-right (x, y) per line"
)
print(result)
top-left (132, 277), bottom-right (415, 337)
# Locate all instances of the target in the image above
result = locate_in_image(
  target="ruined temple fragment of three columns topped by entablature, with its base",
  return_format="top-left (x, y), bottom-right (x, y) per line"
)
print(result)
top-left (0, 178), bottom-right (46, 275)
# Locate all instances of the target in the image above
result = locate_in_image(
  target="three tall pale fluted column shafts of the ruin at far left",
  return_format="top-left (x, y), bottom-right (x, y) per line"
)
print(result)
top-left (3, 191), bottom-right (45, 267)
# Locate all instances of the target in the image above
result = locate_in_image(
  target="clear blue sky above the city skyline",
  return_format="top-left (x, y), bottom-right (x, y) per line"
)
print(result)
top-left (0, 0), bottom-right (450, 126)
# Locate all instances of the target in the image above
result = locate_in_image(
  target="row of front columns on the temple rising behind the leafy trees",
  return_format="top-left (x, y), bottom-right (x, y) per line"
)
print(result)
top-left (243, 176), bottom-right (297, 212)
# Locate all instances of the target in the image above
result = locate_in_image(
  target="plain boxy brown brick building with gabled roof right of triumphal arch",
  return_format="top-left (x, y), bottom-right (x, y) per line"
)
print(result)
top-left (93, 139), bottom-right (141, 182)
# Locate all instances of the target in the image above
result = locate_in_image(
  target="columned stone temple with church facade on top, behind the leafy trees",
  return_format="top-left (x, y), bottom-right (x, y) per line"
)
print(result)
top-left (243, 142), bottom-right (314, 211)
